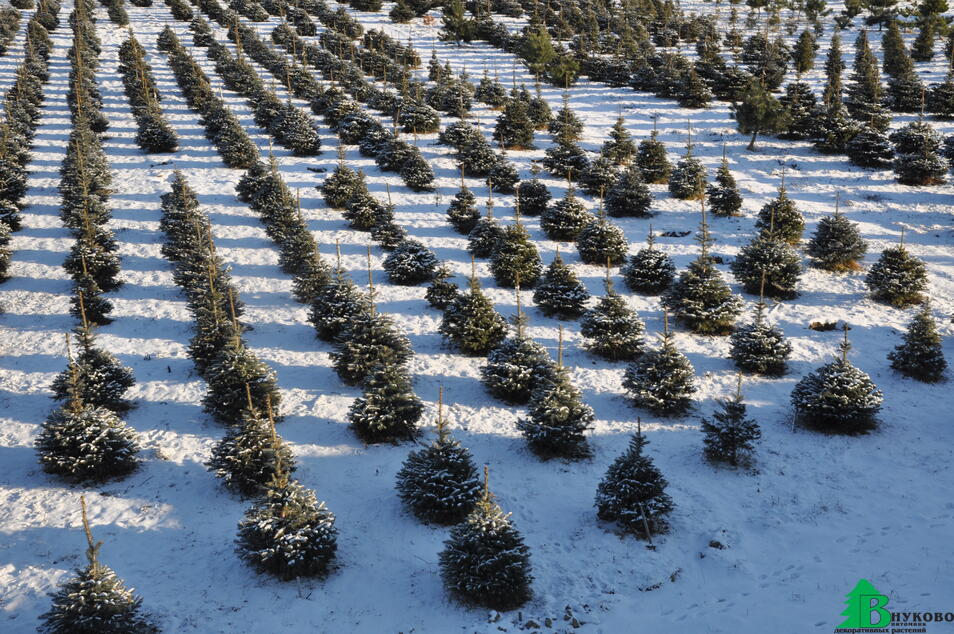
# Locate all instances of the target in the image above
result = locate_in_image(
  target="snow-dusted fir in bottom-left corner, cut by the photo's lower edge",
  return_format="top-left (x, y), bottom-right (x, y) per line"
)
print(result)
top-left (38, 495), bottom-right (160, 634)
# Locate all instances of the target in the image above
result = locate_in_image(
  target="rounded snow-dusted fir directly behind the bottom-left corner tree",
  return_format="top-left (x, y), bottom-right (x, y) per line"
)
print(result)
top-left (36, 341), bottom-right (139, 482)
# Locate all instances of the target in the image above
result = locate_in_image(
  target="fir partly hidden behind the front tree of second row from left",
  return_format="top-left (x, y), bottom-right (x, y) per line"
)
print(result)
top-left (206, 390), bottom-right (295, 497)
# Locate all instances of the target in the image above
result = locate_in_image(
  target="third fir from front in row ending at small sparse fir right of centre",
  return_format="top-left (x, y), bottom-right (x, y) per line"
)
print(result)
top-left (580, 266), bottom-right (646, 361)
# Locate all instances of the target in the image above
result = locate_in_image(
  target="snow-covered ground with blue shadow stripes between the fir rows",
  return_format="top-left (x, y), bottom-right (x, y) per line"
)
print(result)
top-left (0, 2), bottom-right (954, 633)
